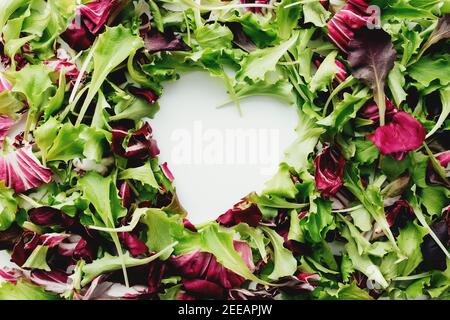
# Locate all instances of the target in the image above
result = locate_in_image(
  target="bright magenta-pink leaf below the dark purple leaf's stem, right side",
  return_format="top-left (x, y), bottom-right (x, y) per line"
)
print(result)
top-left (368, 111), bottom-right (426, 155)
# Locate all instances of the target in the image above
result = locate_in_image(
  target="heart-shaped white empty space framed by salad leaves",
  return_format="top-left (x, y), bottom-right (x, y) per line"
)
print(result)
top-left (149, 72), bottom-right (298, 223)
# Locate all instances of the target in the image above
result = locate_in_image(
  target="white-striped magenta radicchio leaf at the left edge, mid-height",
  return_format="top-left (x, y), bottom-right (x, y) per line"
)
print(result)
top-left (0, 147), bottom-right (52, 193)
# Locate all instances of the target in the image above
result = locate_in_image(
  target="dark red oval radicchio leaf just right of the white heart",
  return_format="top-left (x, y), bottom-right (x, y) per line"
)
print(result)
top-left (314, 145), bottom-right (345, 197)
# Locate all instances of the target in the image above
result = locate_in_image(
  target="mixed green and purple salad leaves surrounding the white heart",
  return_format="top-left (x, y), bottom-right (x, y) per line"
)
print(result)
top-left (0, 0), bottom-right (450, 299)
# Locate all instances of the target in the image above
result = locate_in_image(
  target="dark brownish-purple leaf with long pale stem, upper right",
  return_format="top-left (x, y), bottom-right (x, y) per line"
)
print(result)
top-left (348, 28), bottom-right (397, 126)
